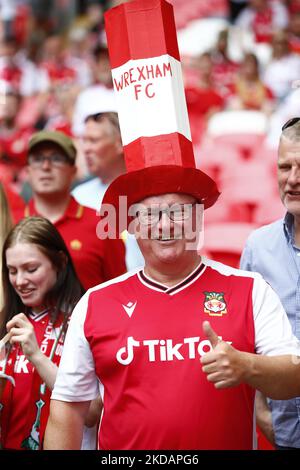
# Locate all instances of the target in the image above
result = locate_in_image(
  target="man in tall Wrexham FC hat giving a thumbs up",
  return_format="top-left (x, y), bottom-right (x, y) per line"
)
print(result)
top-left (45, 0), bottom-right (300, 450)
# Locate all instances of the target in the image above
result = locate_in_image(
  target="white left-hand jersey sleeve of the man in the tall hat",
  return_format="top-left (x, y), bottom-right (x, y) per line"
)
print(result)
top-left (51, 292), bottom-right (99, 402)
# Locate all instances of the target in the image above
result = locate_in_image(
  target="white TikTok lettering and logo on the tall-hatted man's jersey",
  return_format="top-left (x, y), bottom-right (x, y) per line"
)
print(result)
top-left (116, 336), bottom-right (231, 366)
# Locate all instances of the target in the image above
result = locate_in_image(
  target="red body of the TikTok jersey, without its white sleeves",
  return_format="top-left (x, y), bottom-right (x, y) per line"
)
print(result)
top-left (84, 265), bottom-right (254, 449)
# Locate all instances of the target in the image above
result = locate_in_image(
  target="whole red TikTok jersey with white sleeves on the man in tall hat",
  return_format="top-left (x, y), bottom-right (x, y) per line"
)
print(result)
top-left (52, 260), bottom-right (297, 450)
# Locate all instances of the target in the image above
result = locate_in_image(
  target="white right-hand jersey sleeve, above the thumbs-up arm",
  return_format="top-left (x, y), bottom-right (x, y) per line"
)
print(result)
top-left (253, 274), bottom-right (300, 356)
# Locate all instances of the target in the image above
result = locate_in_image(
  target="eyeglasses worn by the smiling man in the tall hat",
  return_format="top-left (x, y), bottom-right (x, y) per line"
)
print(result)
top-left (136, 202), bottom-right (197, 225)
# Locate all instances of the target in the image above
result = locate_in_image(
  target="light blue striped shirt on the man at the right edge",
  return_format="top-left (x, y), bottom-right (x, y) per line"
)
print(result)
top-left (241, 213), bottom-right (300, 448)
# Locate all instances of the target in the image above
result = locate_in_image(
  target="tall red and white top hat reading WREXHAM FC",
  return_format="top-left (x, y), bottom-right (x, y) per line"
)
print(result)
top-left (102, 0), bottom-right (220, 232)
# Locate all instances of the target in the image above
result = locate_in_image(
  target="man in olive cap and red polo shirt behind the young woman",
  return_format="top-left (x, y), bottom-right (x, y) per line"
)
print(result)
top-left (24, 131), bottom-right (126, 289)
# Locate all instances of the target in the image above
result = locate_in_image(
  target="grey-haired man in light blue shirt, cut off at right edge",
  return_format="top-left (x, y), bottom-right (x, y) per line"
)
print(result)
top-left (241, 117), bottom-right (300, 449)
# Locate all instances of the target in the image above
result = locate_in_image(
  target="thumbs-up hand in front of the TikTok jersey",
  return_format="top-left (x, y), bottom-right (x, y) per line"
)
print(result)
top-left (201, 321), bottom-right (247, 389)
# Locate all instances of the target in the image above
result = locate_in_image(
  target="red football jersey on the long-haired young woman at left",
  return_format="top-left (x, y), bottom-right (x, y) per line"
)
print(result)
top-left (0, 311), bottom-right (64, 450)
